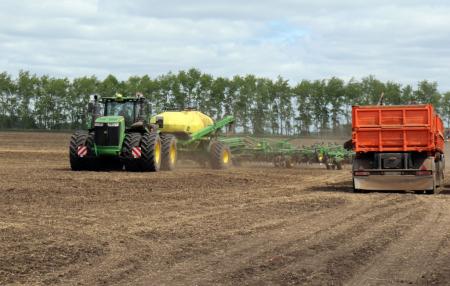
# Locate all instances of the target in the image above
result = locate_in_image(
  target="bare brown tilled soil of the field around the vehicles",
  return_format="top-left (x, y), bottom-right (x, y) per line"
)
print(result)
top-left (0, 133), bottom-right (450, 285)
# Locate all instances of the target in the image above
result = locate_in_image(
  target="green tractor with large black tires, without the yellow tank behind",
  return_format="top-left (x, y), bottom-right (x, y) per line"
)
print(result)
top-left (69, 94), bottom-right (170, 172)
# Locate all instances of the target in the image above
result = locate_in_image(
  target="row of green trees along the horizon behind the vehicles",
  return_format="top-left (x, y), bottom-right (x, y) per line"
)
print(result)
top-left (0, 69), bottom-right (450, 135)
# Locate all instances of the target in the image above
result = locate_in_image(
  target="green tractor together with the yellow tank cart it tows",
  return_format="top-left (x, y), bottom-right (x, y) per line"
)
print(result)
top-left (69, 94), bottom-right (234, 172)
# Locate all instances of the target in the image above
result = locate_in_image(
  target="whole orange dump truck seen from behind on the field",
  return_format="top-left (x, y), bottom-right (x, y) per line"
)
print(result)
top-left (352, 104), bottom-right (445, 194)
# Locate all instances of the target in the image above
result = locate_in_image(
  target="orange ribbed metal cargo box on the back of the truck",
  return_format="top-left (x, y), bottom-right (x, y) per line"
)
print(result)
top-left (352, 104), bottom-right (444, 153)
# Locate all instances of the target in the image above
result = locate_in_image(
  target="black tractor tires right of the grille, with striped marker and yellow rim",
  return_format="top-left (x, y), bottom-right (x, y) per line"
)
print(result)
top-left (122, 132), bottom-right (161, 172)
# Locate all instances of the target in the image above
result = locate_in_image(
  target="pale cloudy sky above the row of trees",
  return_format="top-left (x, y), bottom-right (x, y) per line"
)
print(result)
top-left (0, 0), bottom-right (450, 91)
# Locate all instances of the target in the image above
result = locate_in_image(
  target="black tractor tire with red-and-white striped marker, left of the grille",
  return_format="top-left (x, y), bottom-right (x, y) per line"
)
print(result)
top-left (69, 131), bottom-right (94, 171)
